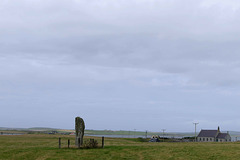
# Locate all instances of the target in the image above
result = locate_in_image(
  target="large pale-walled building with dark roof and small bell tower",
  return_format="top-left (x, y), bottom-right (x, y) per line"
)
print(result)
top-left (197, 127), bottom-right (231, 142)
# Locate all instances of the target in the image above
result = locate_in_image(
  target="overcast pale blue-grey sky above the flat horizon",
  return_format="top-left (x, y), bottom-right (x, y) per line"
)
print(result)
top-left (0, 0), bottom-right (240, 132)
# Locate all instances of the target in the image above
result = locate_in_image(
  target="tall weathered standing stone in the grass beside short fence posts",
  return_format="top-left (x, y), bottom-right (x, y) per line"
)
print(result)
top-left (75, 117), bottom-right (85, 146)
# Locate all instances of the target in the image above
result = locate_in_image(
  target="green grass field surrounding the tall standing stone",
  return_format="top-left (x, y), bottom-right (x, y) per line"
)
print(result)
top-left (0, 134), bottom-right (240, 160)
